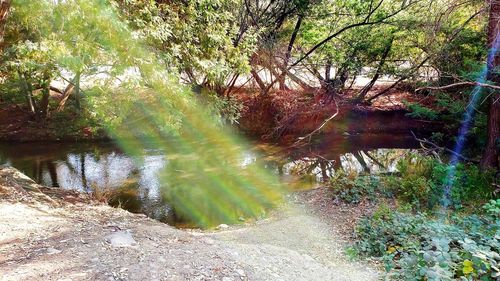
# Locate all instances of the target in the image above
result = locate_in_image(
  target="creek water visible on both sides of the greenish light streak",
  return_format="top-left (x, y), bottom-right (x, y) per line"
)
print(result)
top-left (0, 135), bottom-right (418, 225)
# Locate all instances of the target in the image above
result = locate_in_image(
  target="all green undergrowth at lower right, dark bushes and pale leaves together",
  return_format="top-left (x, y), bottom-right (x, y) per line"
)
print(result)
top-left (330, 155), bottom-right (500, 280)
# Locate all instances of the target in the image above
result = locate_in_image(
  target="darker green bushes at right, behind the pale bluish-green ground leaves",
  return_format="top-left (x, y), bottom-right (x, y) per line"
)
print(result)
top-left (329, 153), bottom-right (494, 211)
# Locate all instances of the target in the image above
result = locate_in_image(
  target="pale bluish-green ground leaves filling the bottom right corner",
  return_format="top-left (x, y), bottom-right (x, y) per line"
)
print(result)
top-left (351, 209), bottom-right (500, 280)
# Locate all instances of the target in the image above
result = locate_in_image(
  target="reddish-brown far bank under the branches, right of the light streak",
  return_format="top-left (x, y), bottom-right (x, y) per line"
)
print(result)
top-left (233, 89), bottom-right (444, 139)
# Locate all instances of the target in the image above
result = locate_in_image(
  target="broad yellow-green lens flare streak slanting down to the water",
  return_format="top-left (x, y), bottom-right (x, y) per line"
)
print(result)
top-left (13, 0), bottom-right (284, 227)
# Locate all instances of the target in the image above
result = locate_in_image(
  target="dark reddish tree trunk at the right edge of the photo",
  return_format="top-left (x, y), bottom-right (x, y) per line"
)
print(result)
top-left (481, 0), bottom-right (500, 168)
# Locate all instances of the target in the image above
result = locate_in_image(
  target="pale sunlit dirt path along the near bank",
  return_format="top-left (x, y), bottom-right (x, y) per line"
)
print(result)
top-left (0, 169), bottom-right (379, 281)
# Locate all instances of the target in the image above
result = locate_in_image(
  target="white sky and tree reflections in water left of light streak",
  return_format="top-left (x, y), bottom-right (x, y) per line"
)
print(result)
top-left (0, 144), bottom-right (172, 220)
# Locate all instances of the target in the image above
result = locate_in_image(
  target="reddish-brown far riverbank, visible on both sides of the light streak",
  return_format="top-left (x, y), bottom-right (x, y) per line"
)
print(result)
top-left (0, 86), bottom-right (443, 143)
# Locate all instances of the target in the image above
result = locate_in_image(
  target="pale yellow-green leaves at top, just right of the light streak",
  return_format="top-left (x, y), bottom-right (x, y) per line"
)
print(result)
top-left (114, 0), bottom-right (257, 84)
